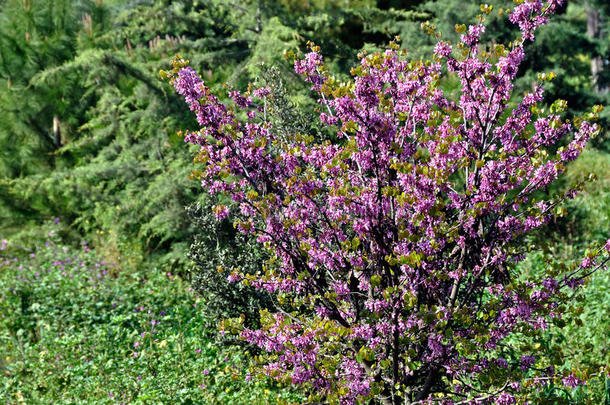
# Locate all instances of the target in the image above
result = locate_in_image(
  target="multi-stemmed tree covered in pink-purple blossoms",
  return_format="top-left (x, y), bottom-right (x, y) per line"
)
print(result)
top-left (163, 0), bottom-right (610, 404)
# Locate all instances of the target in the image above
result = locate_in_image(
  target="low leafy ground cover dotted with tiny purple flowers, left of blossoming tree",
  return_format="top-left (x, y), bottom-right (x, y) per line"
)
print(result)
top-left (0, 222), bottom-right (299, 404)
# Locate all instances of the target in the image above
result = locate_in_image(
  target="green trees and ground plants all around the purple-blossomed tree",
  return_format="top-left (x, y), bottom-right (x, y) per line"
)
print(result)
top-left (0, 0), bottom-right (610, 404)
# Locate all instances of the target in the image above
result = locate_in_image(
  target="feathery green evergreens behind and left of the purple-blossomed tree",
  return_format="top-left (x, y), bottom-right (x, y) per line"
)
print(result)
top-left (0, 0), bottom-right (422, 265)
